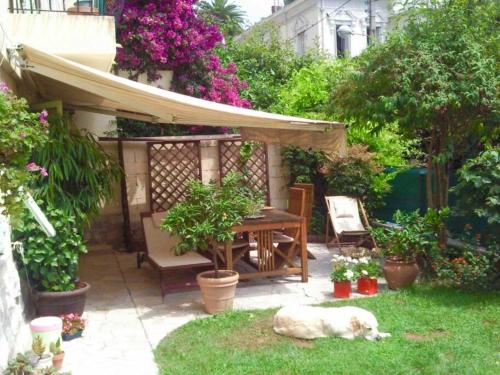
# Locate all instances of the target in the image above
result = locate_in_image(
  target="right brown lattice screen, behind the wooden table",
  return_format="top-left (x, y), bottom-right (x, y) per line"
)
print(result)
top-left (219, 139), bottom-right (270, 204)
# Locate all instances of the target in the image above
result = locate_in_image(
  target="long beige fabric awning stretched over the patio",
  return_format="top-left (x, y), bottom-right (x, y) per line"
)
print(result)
top-left (21, 44), bottom-right (346, 154)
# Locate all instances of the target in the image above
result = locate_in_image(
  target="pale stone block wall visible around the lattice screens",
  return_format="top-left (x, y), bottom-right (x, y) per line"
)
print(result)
top-left (86, 136), bottom-right (288, 248)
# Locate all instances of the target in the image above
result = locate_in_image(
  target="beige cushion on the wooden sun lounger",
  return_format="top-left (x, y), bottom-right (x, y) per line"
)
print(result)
top-left (142, 213), bottom-right (212, 268)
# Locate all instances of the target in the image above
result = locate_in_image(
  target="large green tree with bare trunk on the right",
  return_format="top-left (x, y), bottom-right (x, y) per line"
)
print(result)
top-left (330, 0), bottom-right (500, 212)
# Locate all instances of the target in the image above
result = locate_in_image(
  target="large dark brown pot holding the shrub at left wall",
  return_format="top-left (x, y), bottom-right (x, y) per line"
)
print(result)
top-left (35, 282), bottom-right (90, 316)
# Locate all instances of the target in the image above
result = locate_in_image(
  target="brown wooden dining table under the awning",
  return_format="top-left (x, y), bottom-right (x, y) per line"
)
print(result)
top-left (224, 209), bottom-right (308, 282)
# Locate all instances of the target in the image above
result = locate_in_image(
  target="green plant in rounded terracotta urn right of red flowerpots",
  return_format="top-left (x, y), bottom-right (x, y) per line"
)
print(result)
top-left (371, 209), bottom-right (449, 289)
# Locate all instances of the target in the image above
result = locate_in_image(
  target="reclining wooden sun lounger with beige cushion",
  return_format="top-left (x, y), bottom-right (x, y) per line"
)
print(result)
top-left (137, 212), bottom-right (213, 296)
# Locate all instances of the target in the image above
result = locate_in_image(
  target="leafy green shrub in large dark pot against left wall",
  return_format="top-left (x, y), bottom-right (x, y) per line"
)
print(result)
top-left (15, 206), bottom-right (90, 316)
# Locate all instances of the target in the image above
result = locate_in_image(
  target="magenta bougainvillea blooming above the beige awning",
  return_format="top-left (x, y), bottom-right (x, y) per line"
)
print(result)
top-left (116, 0), bottom-right (251, 133)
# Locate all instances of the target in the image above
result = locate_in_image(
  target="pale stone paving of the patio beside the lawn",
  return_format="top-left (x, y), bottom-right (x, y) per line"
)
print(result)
top-left (64, 244), bottom-right (382, 375)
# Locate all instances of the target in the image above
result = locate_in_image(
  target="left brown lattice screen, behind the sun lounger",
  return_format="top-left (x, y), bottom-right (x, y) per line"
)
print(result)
top-left (147, 141), bottom-right (201, 212)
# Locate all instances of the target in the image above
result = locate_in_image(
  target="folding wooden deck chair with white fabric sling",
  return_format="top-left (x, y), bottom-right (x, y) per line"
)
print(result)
top-left (325, 195), bottom-right (375, 249)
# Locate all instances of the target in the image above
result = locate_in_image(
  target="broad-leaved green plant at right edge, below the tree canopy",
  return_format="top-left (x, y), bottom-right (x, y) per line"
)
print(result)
top-left (452, 147), bottom-right (500, 225)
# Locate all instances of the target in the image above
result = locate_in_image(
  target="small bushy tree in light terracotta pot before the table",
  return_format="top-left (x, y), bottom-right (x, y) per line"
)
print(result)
top-left (162, 173), bottom-right (262, 314)
